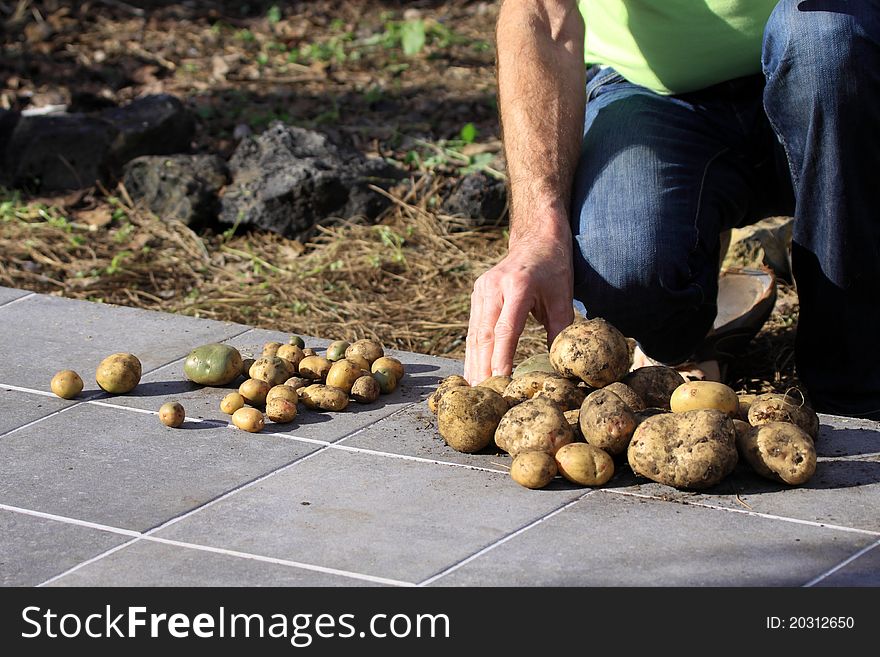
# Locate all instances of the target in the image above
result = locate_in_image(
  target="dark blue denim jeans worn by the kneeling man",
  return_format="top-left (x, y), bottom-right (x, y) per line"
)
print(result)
top-left (572, 0), bottom-right (880, 419)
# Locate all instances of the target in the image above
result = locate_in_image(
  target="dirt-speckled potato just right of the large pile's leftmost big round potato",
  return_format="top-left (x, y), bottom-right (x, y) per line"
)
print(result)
top-left (495, 397), bottom-right (573, 456)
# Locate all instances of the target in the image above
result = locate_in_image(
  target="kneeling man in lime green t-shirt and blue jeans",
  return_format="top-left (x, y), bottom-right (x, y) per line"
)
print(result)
top-left (465, 0), bottom-right (880, 419)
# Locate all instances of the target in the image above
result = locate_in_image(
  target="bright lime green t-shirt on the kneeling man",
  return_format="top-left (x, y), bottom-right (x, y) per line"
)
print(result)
top-left (578, 0), bottom-right (777, 94)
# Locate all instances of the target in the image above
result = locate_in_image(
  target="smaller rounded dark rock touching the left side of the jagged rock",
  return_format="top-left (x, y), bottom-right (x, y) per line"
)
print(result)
top-left (122, 155), bottom-right (229, 228)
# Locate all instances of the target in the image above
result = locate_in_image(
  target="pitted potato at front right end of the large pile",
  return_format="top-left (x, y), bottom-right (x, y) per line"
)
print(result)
top-left (736, 422), bottom-right (816, 486)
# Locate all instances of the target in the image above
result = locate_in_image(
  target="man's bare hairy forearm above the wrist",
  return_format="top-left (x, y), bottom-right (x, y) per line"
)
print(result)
top-left (496, 0), bottom-right (586, 245)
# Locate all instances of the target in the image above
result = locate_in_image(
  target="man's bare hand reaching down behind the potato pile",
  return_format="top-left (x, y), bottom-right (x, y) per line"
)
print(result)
top-left (464, 235), bottom-right (574, 385)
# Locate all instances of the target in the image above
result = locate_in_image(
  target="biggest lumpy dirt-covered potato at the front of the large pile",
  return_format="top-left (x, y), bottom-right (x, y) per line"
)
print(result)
top-left (627, 409), bottom-right (738, 490)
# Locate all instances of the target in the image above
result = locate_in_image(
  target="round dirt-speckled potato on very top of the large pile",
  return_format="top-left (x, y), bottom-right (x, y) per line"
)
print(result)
top-left (550, 317), bottom-right (632, 388)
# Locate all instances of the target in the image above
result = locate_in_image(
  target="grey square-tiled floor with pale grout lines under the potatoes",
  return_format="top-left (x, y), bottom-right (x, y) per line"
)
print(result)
top-left (0, 288), bottom-right (880, 587)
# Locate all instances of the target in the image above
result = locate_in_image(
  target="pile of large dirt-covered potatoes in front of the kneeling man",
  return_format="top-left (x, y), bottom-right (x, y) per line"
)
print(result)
top-left (427, 318), bottom-right (819, 490)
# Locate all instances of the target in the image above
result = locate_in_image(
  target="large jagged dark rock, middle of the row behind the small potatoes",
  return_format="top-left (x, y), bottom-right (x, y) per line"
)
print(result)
top-left (220, 122), bottom-right (404, 239)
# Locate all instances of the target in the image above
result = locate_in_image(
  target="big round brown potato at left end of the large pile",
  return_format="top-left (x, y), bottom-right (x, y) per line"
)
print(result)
top-left (434, 386), bottom-right (508, 453)
